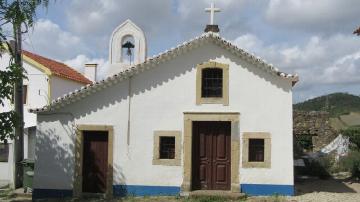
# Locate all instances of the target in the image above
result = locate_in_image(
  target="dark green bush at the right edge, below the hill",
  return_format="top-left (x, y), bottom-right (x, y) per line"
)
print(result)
top-left (340, 151), bottom-right (360, 178)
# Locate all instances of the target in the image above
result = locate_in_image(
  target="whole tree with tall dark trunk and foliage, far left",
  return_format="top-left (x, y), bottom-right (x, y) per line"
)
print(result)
top-left (0, 0), bottom-right (48, 188)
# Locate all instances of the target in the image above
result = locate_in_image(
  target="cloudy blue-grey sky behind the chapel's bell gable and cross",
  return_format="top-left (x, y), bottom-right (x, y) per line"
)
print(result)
top-left (24, 0), bottom-right (360, 103)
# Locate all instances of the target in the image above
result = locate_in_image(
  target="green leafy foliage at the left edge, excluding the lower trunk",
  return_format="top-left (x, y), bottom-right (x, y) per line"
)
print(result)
top-left (0, 0), bottom-right (48, 142)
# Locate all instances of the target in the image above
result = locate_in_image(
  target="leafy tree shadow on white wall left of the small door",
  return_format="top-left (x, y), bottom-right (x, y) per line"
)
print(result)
top-left (33, 126), bottom-right (75, 199)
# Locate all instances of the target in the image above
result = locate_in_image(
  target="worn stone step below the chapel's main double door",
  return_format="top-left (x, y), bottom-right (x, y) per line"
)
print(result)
top-left (189, 190), bottom-right (245, 200)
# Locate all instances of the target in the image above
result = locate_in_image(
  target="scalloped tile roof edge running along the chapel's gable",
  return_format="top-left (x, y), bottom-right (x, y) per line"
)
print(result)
top-left (29, 32), bottom-right (299, 113)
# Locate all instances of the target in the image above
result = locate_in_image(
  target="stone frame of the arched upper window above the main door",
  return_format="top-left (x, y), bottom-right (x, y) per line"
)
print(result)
top-left (196, 61), bottom-right (229, 106)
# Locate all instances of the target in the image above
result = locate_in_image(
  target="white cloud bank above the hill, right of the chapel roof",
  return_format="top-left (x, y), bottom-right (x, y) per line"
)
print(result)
top-left (234, 34), bottom-right (360, 89)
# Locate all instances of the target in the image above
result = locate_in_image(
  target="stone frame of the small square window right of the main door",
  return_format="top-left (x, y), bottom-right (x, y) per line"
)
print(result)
top-left (242, 132), bottom-right (271, 168)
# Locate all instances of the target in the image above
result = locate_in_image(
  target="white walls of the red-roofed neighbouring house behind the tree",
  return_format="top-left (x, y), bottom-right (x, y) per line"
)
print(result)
top-left (0, 53), bottom-right (84, 184)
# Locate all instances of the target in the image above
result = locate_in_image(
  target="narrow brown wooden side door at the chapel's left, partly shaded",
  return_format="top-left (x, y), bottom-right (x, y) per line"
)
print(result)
top-left (82, 131), bottom-right (108, 193)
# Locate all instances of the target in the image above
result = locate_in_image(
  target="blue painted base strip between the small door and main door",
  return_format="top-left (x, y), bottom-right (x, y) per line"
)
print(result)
top-left (113, 185), bottom-right (180, 196)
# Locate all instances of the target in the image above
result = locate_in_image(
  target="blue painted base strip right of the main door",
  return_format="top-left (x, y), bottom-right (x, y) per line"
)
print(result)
top-left (241, 184), bottom-right (294, 196)
